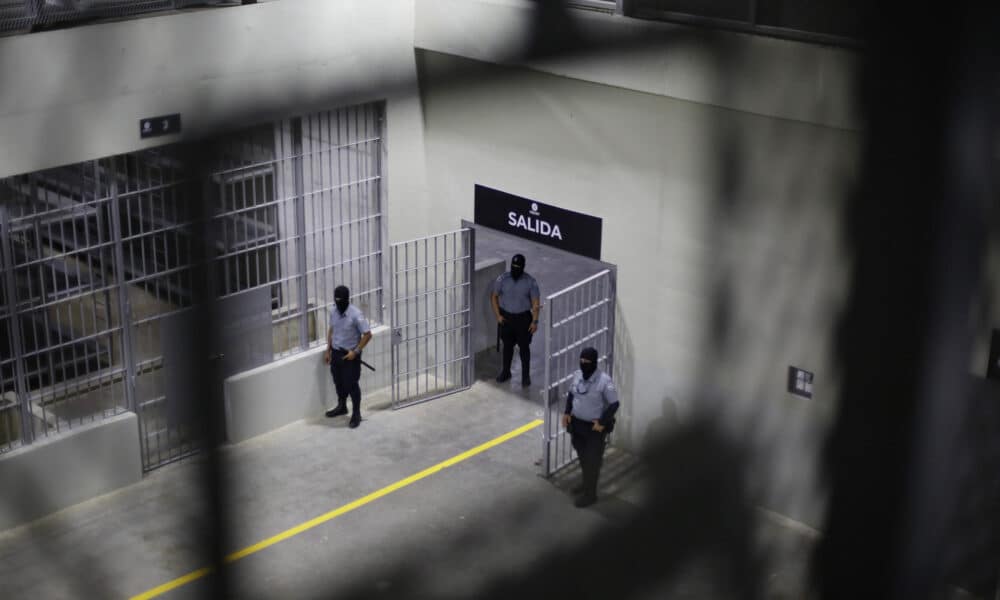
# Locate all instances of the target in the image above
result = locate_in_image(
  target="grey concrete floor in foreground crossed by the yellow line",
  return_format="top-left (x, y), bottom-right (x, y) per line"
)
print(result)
top-left (0, 382), bottom-right (812, 598)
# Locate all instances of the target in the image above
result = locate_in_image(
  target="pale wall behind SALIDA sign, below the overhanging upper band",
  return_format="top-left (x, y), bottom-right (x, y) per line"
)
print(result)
top-left (418, 52), bottom-right (861, 524)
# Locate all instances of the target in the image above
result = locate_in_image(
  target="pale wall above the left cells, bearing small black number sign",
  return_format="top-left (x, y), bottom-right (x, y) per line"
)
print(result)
top-left (0, 0), bottom-right (425, 220)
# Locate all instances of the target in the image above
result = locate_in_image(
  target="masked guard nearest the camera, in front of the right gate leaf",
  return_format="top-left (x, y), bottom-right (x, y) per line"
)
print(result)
top-left (563, 348), bottom-right (618, 508)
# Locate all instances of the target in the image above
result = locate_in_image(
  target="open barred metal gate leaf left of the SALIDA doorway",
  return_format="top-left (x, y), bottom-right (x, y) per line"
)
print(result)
top-left (390, 229), bottom-right (475, 409)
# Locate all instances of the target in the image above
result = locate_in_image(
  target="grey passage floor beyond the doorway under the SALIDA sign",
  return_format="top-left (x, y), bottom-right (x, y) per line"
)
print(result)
top-left (474, 226), bottom-right (607, 390)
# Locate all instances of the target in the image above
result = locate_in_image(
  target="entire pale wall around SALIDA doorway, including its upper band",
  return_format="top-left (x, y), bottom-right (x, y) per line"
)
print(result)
top-left (415, 0), bottom-right (861, 525)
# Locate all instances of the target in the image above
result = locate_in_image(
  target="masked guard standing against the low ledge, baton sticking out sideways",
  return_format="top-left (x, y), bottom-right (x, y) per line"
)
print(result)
top-left (324, 285), bottom-right (372, 429)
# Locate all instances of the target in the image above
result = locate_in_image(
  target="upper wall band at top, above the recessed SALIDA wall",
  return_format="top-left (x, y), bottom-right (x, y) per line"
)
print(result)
top-left (414, 0), bottom-right (860, 129)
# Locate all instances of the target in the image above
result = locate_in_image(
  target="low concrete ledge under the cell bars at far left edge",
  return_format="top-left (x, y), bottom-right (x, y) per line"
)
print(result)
top-left (0, 413), bottom-right (142, 530)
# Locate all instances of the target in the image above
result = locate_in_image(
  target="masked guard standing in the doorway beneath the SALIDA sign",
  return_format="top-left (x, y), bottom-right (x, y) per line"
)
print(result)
top-left (490, 254), bottom-right (541, 387)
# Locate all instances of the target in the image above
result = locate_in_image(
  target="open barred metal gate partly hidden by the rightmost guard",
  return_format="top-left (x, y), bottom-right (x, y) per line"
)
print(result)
top-left (540, 269), bottom-right (615, 477)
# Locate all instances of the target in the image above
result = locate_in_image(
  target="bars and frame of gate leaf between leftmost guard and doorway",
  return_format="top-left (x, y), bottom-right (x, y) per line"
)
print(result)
top-left (388, 227), bottom-right (476, 410)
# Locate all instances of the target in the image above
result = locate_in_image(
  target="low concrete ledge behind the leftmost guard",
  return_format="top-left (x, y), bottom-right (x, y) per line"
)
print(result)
top-left (224, 325), bottom-right (392, 443)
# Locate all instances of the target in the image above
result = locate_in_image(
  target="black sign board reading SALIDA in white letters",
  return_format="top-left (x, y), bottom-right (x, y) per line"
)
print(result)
top-left (475, 185), bottom-right (602, 260)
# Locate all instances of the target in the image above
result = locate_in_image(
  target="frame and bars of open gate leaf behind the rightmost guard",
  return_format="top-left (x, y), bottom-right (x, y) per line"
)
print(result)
top-left (539, 265), bottom-right (617, 477)
